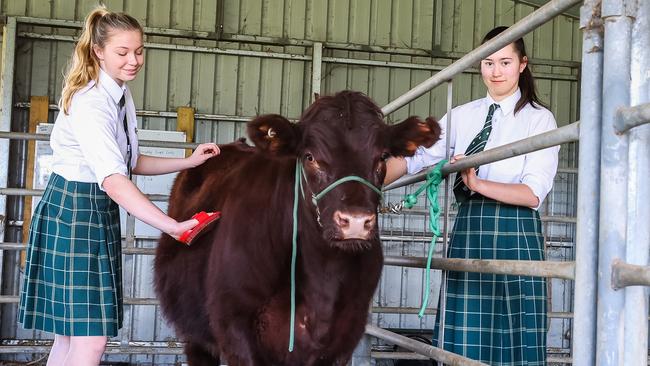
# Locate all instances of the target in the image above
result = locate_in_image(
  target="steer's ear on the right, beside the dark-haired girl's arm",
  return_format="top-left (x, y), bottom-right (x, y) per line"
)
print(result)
top-left (388, 117), bottom-right (440, 156)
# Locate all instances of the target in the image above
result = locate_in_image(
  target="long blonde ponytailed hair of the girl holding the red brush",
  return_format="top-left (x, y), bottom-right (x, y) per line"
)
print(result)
top-left (59, 6), bottom-right (143, 114)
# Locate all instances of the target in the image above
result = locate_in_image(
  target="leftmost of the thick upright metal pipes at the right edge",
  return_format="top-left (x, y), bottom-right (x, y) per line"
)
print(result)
top-left (571, 0), bottom-right (603, 366)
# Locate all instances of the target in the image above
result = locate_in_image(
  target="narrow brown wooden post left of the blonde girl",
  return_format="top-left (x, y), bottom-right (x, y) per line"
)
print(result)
top-left (20, 96), bottom-right (50, 267)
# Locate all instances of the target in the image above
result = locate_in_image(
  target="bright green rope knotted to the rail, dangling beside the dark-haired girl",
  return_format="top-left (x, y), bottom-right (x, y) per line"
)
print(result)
top-left (404, 160), bottom-right (447, 318)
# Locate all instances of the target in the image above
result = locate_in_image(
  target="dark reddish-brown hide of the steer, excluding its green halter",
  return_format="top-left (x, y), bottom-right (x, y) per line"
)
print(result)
top-left (154, 91), bottom-right (440, 366)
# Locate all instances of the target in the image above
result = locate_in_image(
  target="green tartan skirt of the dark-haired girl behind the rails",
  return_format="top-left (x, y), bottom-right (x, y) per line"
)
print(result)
top-left (434, 195), bottom-right (547, 366)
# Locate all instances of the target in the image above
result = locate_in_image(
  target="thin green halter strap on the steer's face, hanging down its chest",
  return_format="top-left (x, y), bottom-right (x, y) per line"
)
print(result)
top-left (289, 159), bottom-right (383, 352)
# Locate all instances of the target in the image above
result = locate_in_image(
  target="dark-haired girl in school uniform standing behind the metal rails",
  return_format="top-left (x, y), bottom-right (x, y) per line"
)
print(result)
top-left (387, 27), bottom-right (559, 366)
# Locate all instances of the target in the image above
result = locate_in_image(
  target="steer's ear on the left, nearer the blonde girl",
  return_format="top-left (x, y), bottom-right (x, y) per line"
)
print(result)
top-left (247, 114), bottom-right (300, 154)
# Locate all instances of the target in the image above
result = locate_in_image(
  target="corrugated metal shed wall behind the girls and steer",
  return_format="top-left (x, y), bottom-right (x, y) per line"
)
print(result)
top-left (0, 0), bottom-right (581, 363)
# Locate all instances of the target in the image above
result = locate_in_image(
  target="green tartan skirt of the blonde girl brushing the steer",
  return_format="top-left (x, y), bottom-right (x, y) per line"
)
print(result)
top-left (19, 173), bottom-right (122, 337)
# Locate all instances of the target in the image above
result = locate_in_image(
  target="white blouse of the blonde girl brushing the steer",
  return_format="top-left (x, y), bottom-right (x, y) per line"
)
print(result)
top-left (50, 69), bottom-right (139, 189)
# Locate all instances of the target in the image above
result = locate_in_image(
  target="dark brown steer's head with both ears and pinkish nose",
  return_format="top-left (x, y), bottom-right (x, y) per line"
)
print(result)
top-left (248, 91), bottom-right (440, 250)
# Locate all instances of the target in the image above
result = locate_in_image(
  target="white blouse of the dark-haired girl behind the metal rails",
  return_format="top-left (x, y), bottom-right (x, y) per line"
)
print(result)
top-left (406, 89), bottom-right (560, 208)
